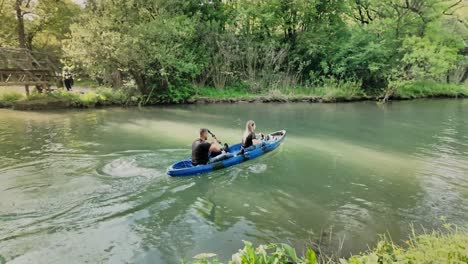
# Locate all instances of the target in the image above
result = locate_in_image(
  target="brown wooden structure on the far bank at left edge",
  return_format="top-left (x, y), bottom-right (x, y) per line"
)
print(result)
top-left (0, 48), bottom-right (62, 94)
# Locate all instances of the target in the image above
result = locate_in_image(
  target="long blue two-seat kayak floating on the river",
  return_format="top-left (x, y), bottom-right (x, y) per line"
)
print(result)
top-left (167, 130), bottom-right (286, 177)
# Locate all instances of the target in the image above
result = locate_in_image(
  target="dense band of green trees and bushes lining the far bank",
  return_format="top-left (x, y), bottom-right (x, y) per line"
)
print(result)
top-left (0, 0), bottom-right (468, 101)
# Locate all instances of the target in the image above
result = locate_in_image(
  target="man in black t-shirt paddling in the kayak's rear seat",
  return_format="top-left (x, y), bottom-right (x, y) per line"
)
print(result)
top-left (192, 128), bottom-right (223, 165)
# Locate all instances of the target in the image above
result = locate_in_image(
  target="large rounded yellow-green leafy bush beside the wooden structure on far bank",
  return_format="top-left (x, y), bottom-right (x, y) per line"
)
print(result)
top-left (65, 0), bottom-right (200, 94)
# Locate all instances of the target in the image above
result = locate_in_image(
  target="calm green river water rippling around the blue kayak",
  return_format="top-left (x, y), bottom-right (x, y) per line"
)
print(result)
top-left (0, 100), bottom-right (468, 263)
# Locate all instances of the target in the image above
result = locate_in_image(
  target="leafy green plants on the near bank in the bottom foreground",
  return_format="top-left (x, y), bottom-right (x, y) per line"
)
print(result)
top-left (193, 227), bottom-right (468, 264)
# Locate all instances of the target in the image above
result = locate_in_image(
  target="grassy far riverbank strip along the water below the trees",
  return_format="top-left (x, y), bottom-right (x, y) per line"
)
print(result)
top-left (0, 83), bottom-right (468, 110)
